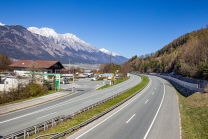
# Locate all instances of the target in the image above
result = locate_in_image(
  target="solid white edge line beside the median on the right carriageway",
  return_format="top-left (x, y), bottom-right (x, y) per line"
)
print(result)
top-left (75, 79), bottom-right (152, 139)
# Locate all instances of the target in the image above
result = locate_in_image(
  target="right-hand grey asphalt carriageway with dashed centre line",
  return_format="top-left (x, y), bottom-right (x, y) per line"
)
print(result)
top-left (67, 76), bottom-right (180, 139)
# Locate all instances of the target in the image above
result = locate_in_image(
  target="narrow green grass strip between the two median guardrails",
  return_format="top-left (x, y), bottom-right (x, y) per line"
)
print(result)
top-left (32, 75), bottom-right (149, 138)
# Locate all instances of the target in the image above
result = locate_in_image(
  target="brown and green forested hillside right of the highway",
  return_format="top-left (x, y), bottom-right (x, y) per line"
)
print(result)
top-left (128, 26), bottom-right (208, 79)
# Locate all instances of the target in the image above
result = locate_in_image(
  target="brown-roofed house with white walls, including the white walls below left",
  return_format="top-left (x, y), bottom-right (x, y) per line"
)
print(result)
top-left (0, 60), bottom-right (64, 92)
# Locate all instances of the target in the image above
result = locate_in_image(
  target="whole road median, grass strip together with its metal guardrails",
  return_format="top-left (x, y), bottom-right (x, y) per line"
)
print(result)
top-left (27, 76), bottom-right (149, 139)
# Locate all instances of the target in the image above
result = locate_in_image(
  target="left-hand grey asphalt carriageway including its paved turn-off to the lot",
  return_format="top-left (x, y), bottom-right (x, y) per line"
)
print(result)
top-left (0, 75), bottom-right (141, 136)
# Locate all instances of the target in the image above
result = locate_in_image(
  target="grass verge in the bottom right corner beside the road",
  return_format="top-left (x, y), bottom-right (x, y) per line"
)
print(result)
top-left (178, 93), bottom-right (208, 139)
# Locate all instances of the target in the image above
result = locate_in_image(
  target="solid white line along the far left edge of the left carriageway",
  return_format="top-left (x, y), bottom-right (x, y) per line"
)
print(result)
top-left (0, 76), bottom-right (140, 124)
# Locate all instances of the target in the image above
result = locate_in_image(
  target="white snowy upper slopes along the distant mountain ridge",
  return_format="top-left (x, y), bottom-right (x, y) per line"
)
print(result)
top-left (28, 27), bottom-right (99, 52)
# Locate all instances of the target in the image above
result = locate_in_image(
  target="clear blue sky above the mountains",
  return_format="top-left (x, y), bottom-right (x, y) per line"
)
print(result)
top-left (0, 0), bottom-right (208, 58)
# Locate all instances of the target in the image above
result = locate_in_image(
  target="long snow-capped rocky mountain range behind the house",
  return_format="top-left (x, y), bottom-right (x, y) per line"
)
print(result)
top-left (0, 23), bottom-right (128, 64)
